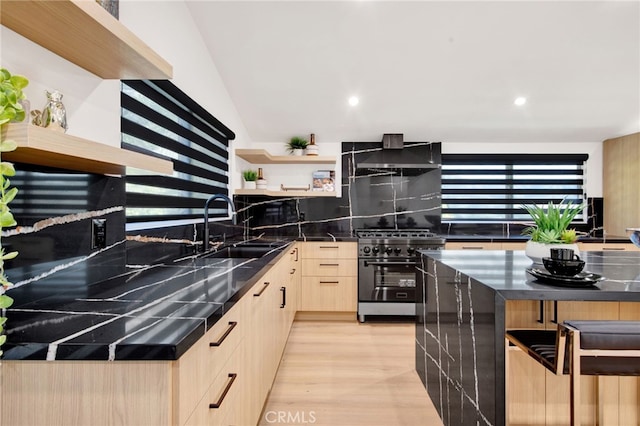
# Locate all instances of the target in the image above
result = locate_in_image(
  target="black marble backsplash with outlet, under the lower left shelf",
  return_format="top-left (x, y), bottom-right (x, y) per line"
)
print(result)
top-left (2, 164), bottom-right (125, 283)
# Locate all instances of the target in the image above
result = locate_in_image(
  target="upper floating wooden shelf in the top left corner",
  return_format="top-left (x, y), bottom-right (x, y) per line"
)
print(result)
top-left (0, 0), bottom-right (173, 80)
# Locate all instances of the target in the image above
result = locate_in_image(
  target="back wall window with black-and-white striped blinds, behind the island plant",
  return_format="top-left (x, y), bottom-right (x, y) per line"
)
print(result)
top-left (442, 154), bottom-right (588, 223)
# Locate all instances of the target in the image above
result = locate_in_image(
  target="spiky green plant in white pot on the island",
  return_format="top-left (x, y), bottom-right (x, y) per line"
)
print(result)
top-left (522, 201), bottom-right (585, 263)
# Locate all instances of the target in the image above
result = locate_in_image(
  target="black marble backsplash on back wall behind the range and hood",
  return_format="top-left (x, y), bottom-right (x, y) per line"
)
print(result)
top-left (235, 142), bottom-right (441, 237)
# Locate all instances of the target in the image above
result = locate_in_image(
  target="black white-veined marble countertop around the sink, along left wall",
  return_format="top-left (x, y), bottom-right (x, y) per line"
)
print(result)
top-left (3, 244), bottom-right (288, 360)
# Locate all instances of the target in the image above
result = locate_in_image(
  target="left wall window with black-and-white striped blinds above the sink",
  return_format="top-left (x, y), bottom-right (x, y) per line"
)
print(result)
top-left (120, 80), bottom-right (235, 229)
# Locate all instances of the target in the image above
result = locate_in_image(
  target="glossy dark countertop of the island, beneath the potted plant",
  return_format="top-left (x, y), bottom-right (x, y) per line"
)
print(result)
top-left (422, 250), bottom-right (640, 301)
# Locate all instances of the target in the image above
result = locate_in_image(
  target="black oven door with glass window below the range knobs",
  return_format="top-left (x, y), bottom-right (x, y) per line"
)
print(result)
top-left (358, 258), bottom-right (416, 303)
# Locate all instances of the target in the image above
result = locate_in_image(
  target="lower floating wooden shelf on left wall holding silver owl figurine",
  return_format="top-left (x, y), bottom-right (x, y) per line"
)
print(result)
top-left (2, 122), bottom-right (173, 175)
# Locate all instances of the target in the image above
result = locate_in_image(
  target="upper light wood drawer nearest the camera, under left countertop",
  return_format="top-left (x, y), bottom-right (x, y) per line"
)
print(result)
top-left (174, 300), bottom-right (247, 425)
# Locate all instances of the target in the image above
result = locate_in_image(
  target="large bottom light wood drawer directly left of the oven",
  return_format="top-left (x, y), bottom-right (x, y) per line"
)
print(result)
top-left (301, 277), bottom-right (358, 312)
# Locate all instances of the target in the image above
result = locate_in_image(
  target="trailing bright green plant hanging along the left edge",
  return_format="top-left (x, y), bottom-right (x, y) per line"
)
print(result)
top-left (0, 68), bottom-right (29, 356)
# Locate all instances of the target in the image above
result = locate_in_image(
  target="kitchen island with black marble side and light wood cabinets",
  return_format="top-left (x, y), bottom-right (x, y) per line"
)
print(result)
top-left (416, 250), bottom-right (640, 425)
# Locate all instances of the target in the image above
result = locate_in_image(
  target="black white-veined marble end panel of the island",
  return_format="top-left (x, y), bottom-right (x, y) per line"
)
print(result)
top-left (416, 256), bottom-right (500, 425)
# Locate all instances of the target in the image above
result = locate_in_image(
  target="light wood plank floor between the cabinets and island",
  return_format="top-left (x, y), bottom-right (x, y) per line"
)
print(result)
top-left (260, 320), bottom-right (442, 426)
